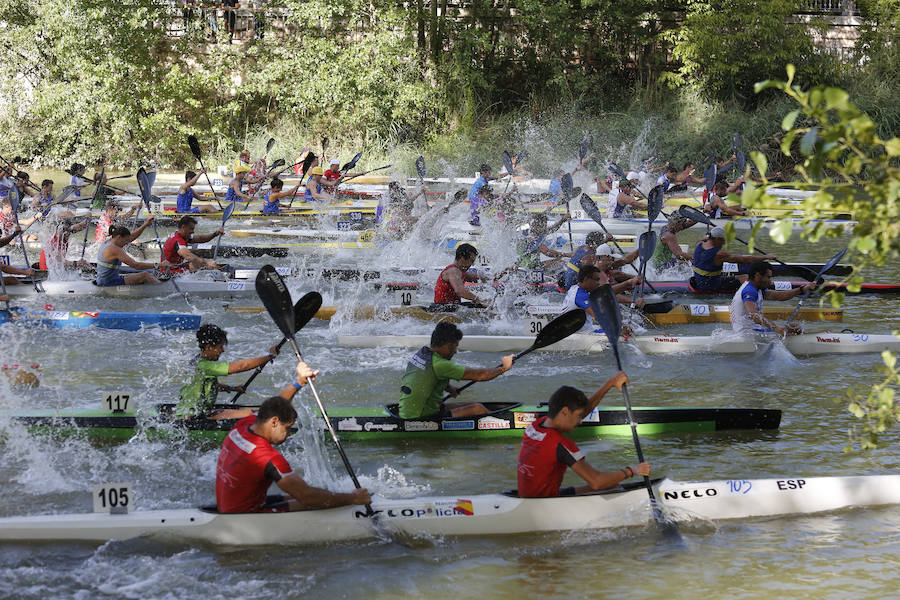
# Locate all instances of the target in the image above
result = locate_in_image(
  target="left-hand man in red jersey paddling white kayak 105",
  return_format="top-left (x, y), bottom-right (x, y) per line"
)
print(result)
top-left (216, 362), bottom-right (372, 513)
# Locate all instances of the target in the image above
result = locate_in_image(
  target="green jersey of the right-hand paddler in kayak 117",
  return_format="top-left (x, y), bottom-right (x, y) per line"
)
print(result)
top-left (400, 346), bottom-right (466, 419)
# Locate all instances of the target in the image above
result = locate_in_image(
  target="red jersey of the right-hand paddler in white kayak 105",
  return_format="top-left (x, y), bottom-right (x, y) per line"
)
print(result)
top-left (518, 417), bottom-right (584, 498)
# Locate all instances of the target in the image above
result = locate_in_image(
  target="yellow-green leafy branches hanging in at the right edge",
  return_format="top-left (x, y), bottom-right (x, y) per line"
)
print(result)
top-left (745, 65), bottom-right (900, 448)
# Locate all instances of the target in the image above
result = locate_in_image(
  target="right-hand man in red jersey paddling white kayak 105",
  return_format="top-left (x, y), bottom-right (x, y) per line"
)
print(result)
top-left (518, 371), bottom-right (650, 498)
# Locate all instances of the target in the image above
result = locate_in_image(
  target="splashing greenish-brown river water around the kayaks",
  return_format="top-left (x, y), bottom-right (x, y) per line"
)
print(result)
top-left (0, 170), bottom-right (900, 599)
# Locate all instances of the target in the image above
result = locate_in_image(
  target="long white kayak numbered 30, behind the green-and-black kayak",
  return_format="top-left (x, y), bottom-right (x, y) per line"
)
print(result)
top-left (338, 332), bottom-right (900, 355)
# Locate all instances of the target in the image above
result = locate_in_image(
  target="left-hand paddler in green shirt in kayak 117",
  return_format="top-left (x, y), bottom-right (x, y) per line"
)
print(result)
top-left (175, 324), bottom-right (278, 419)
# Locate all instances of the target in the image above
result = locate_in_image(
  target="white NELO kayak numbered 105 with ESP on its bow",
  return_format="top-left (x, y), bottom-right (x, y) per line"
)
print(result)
top-left (0, 474), bottom-right (900, 545)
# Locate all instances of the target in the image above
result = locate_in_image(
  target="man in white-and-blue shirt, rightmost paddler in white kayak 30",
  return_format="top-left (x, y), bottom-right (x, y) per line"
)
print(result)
top-left (730, 262), bottom-right (817, 337)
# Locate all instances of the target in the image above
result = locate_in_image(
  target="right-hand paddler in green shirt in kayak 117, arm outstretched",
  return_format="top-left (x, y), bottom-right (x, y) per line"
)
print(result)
top-left (400, 322), bottom-right (515, 419)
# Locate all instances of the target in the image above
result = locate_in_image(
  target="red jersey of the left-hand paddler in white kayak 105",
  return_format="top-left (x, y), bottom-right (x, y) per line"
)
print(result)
top-left (216, 415), bottom-right (293, 513)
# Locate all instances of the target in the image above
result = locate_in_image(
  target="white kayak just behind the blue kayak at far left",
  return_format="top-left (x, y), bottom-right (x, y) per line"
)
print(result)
top-left (6, 279), bottom-right (256, 298)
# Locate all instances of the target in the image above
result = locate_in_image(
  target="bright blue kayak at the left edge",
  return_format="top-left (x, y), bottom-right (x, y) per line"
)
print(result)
top-left (0, 308), bottom-right (200, 331)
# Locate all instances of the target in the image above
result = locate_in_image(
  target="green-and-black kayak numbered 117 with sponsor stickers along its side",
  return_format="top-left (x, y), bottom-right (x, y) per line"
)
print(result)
top-left (3, 402), bottom-right (781, 441)
